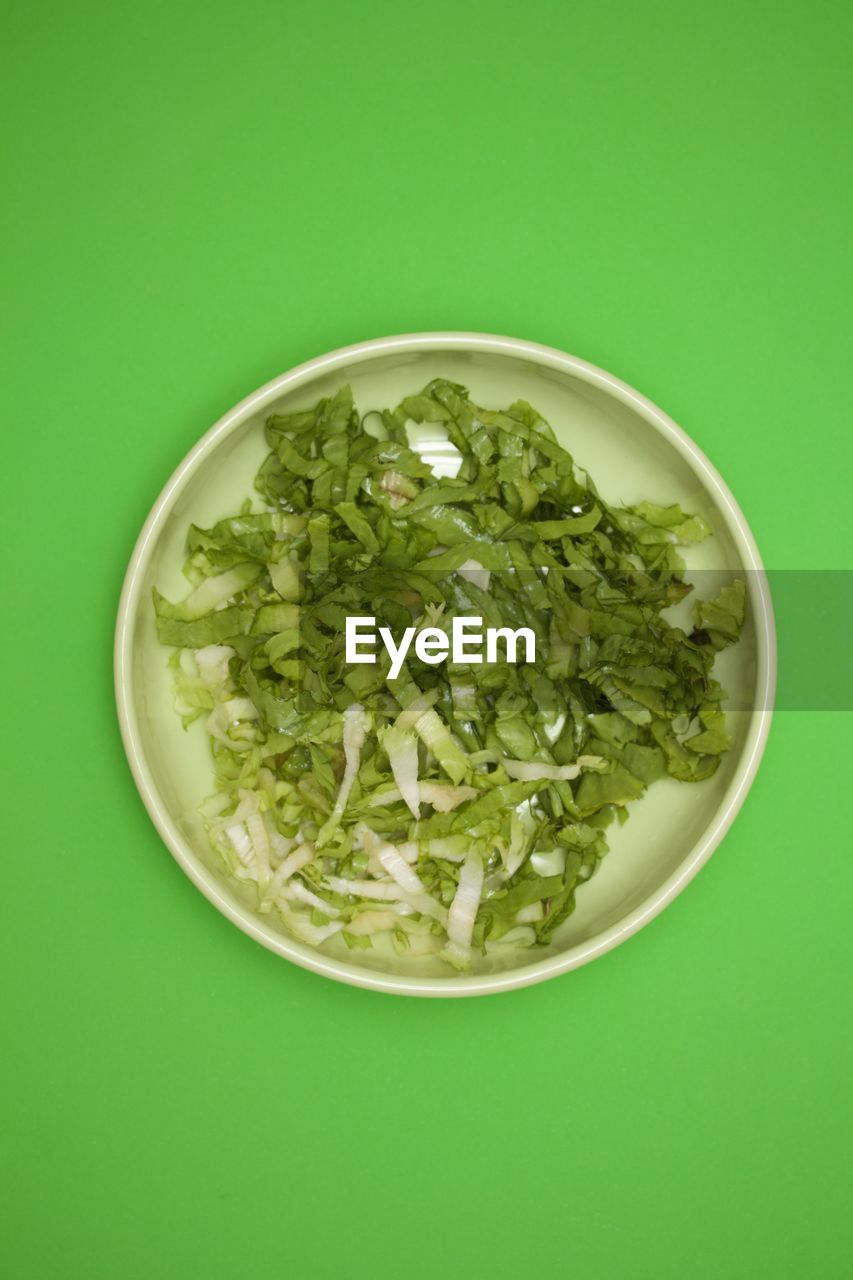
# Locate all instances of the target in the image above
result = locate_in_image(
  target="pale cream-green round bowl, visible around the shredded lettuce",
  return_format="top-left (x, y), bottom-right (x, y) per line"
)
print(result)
top-left (115, 333), bottom-right (776, 996)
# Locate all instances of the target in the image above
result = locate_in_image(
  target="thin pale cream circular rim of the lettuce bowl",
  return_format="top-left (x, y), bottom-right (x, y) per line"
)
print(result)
top-left (114, 330), bottom-right (776, 997)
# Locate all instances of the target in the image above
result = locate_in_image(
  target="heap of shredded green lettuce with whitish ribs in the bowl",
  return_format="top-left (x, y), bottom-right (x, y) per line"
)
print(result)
top-left (154, 379), bottom-right (744, 972)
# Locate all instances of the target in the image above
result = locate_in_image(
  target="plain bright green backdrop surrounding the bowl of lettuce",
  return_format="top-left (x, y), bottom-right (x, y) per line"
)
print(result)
top-left (0, 0), bottom-right (853, 1280)
